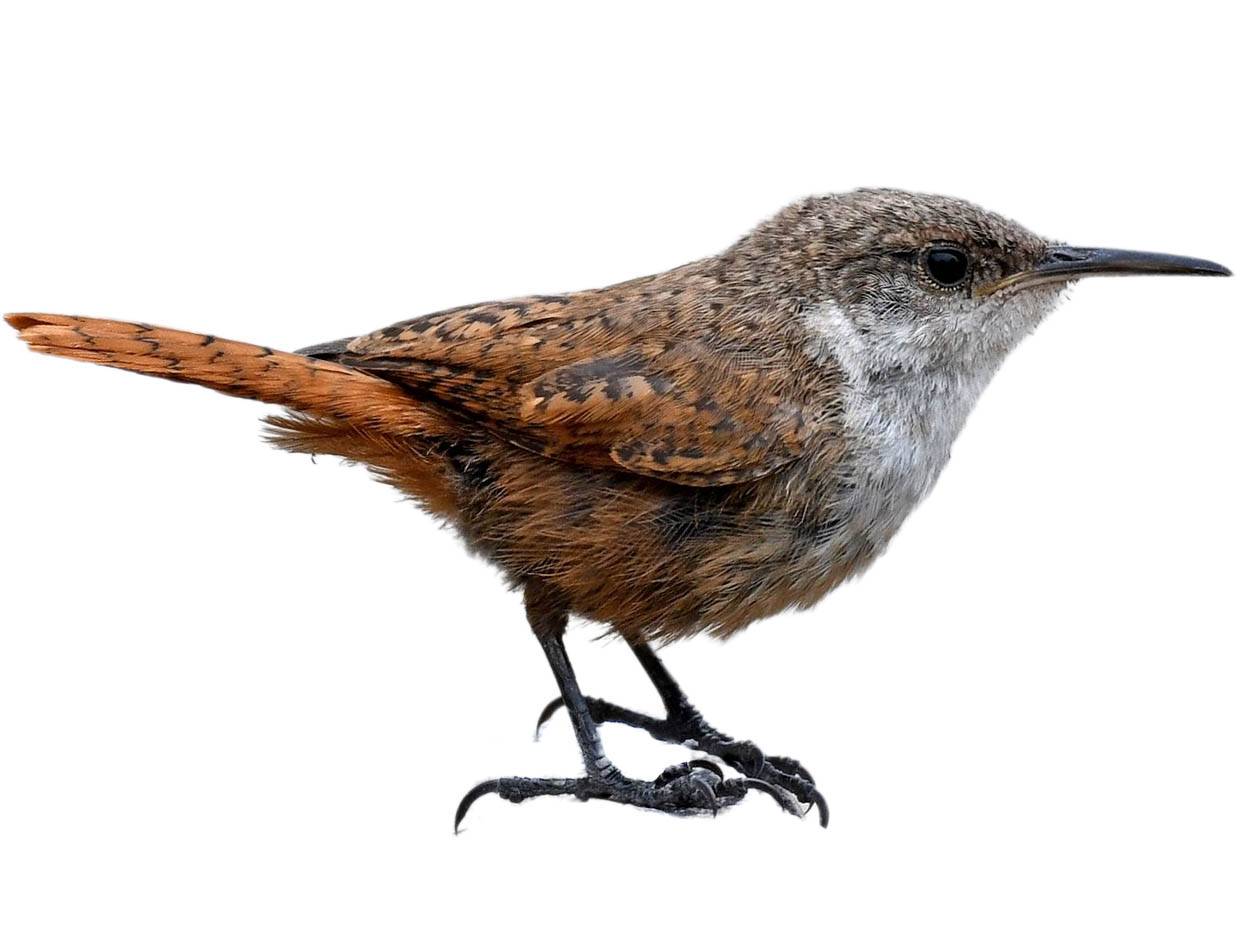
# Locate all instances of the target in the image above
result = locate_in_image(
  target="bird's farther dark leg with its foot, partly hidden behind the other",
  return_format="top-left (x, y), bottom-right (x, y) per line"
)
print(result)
top-left (535, 642), bottom-right (830, 828)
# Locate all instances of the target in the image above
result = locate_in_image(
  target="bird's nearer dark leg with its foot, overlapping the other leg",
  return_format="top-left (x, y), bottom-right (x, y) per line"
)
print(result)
top-left (453, 588), bottom-right (800, 830)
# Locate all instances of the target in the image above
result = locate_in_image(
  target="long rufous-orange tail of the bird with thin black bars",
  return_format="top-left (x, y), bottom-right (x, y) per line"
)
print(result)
top-left (5, 313), bottom-right (448, 437)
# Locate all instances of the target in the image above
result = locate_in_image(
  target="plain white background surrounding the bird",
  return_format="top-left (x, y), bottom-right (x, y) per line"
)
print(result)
top-left (0, 3), bottom-right (1252, 939)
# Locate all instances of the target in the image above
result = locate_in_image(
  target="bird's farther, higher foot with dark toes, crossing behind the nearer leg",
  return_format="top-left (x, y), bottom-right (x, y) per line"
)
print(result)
top-left (535, 697), bottom-right (830, 828)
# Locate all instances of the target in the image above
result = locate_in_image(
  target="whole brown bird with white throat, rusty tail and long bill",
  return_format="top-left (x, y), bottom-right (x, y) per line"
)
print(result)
top-left (6, 189), bottom-right (1231, 831)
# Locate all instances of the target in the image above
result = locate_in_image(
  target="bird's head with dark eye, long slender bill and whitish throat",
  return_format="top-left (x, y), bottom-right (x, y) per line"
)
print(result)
top-left (736, 189), bottom-right (1231, 372)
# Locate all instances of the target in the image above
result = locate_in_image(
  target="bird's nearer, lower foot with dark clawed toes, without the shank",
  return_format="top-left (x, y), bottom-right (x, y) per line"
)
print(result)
top-left (453, 760), bottom-right (801, 830)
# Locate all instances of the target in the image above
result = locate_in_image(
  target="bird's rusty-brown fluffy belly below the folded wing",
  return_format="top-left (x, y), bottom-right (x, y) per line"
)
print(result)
top-left (457, 441), bottom-right (868, 640)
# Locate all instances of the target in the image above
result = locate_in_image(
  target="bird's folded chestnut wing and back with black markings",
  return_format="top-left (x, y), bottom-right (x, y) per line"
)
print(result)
top-left (315, 269), bottom-right (813, 486)
